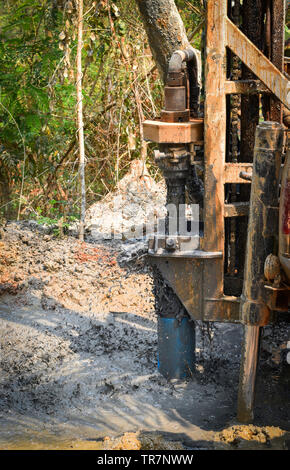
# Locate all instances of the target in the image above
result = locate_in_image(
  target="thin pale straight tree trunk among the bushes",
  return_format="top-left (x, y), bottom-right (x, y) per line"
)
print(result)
top-left (77, 0), bottom-right (86, 241)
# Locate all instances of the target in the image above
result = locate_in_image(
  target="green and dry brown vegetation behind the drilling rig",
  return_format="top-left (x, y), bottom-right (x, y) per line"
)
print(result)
top-left (0, 0), bottom-right (204, 220)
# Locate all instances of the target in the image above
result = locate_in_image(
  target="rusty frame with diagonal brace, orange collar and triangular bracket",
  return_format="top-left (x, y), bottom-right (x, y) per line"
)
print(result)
top-left (144, 0), bottom-right (290, 321)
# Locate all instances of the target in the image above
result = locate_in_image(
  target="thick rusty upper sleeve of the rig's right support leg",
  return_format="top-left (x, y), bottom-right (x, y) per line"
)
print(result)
top-left (241, 121), bottom-right (284, 326)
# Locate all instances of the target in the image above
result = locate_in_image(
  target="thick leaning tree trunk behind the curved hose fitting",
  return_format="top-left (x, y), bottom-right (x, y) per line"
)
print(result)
top-left (136, 0), bottom-right (189, 82)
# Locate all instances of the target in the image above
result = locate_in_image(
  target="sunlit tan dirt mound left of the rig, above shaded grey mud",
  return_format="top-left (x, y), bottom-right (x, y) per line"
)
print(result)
top-left (0, 223), bottom-right (153, 315)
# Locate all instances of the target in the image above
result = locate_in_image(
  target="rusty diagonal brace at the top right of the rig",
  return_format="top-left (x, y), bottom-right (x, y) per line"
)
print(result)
top-left (225, 18), bottom-right (290, 109)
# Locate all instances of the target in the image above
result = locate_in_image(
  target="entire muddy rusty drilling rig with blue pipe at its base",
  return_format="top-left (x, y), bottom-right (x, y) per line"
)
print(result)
top-left (143, 0), bottom-right (290, 422)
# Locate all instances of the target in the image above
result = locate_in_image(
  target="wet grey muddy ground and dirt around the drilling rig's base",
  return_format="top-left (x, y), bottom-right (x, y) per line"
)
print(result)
top-left (0, 223), bottom-right (290, 449)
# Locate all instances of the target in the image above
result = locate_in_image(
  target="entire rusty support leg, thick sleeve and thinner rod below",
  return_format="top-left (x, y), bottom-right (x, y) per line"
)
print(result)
top-left (238, 122), bottom-right (284, 423)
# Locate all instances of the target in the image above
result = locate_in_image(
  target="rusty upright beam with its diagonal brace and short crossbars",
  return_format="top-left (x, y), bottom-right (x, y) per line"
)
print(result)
top-left (202, 0), bottom-right (290, 321)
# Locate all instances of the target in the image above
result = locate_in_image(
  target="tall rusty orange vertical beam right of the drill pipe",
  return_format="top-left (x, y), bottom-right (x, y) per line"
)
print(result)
top-left (203, 0), bottom-right (227, 298)
